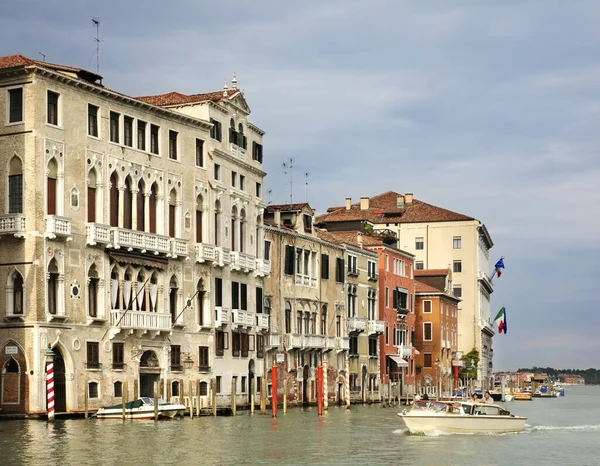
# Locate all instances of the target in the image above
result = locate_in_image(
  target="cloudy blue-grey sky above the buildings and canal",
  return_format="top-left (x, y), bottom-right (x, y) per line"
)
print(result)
top-left (0, 0), bottom-right (600, 370)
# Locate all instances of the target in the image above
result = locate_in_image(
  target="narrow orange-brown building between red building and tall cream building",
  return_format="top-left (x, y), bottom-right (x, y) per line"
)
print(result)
top-left (414, 269), bottom-right (460, 395)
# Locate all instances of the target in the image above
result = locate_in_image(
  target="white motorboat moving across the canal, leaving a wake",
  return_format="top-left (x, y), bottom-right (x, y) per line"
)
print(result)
top-left (398, 400), bottom-right (527, 434)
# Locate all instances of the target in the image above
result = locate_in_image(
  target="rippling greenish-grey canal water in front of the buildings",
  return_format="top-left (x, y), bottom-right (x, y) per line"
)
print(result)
top-left (0, 387), bottom-right (600, 466)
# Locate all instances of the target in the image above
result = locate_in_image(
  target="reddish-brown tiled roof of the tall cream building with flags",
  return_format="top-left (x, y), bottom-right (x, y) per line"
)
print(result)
top-left (316, 191), bottom-right (475, 224)
